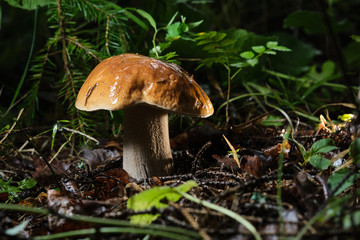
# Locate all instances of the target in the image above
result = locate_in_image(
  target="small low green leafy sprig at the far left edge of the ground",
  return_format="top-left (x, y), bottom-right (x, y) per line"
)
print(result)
top-left (0, 178), bottom-right (37, 201)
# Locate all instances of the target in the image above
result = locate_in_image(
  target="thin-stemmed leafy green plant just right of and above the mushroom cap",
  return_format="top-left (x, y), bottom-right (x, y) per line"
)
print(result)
top-left (195, 29), bottom-right (290, 124)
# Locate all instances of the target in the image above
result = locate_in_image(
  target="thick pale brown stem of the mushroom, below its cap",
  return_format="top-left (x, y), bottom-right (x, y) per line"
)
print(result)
top-left (123, 104), bottom-right (172, 179)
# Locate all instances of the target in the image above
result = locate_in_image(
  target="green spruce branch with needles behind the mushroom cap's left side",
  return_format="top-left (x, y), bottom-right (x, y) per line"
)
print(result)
top-left (16, 0), bottom-right (146, 135)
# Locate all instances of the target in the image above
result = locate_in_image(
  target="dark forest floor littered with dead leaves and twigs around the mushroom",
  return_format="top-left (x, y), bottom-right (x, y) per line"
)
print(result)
top-left (0, 113), bottom-right (360, 239)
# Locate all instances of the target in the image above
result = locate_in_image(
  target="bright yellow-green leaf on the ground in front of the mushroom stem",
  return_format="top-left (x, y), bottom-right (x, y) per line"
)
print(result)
top-left (127, 180), bottom-right (197, 224)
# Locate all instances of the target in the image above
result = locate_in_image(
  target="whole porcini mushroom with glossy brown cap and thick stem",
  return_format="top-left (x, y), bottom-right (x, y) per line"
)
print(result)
top-left (75, 53), bottom-right (214, 179)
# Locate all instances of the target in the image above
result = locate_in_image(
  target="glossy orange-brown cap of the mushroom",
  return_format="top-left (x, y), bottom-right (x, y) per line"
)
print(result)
top-left (75, 53), bottom-right (214, 117)
